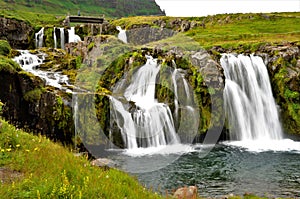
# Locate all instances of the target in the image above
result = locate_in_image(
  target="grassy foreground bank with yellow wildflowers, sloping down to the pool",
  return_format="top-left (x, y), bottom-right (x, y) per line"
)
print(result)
top-left (0, 120), bottom-right (161, 198)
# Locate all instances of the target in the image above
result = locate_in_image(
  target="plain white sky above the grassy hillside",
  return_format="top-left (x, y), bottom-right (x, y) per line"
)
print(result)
top-left (156, 0), bottom-right (300, 17)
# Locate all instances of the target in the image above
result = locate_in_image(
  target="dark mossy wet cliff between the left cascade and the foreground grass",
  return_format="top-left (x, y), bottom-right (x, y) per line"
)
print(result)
top-left (0, 71), bottom-right (74, 144)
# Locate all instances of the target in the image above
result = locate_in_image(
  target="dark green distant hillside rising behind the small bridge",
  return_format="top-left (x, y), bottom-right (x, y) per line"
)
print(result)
top-left (0, 0), bottom-right (165, 17)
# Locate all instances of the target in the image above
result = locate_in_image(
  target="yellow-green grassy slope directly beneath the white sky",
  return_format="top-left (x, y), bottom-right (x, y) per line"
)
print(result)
top-left (112, 12), bottom-right (300, 48)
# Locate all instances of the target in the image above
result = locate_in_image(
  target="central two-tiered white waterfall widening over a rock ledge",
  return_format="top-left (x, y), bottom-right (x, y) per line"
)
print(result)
top-left (110, 56), bottom-right (179, 149)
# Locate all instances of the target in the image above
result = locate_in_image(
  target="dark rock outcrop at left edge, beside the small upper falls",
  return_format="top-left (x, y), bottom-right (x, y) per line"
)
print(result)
top-left (0, 17), bottom-right (34, 49)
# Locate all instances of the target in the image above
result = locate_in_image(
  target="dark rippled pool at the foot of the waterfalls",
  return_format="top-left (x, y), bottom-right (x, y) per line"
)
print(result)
top-left (111, 142), bottom-right (300, 197)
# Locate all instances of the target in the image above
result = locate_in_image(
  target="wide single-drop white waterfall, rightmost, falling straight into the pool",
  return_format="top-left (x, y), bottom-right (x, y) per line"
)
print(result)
top-left (221, 54), bottom-right (282, 141)
